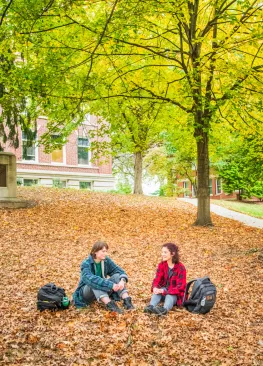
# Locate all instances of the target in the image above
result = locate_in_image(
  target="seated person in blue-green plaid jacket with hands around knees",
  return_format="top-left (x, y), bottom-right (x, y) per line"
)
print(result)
top-left (73, 241), bottom-right (134, 314)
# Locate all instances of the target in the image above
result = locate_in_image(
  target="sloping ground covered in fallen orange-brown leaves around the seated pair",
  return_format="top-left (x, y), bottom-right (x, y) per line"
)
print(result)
top-left (0, 188), bottom-right (263, 366)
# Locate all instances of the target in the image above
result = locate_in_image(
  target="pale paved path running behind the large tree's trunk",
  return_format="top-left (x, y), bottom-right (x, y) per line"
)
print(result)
top-left (178, 198), bottom-right (263, 229)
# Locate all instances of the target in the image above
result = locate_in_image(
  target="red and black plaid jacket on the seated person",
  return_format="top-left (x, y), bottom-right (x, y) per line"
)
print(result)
top-left (152, 261), bottom-right (186, 306)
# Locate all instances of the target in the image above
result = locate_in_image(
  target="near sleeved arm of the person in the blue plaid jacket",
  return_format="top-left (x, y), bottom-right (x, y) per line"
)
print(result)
top-left (81, 261), bottom-right (114, 292)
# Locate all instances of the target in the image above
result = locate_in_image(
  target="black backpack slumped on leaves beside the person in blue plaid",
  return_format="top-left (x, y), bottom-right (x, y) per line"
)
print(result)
top-left (37, 283), bottom-right (69, 311)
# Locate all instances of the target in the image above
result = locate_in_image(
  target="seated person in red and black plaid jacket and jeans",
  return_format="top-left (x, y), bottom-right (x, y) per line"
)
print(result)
top-left (144, 243), bottom-right (186, 315)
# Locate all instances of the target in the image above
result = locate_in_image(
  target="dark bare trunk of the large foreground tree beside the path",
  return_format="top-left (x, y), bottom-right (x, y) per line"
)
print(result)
top-left (194, 129), bottom-right (213, 226)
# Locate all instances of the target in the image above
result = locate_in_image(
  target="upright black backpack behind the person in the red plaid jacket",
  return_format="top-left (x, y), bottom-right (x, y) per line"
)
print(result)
top-left (183, 276), bottom-right (216, 314)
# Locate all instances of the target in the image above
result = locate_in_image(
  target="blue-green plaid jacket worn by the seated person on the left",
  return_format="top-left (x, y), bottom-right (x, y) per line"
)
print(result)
top-left (73, 255), bottom-right (128, 308)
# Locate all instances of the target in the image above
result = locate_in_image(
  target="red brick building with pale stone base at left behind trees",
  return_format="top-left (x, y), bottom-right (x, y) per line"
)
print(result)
top-left (2, 116), bottom-right (114, 191)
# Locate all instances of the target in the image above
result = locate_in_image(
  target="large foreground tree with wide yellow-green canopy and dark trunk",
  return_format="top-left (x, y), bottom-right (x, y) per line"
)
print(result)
top-left (8, 0), bottom-right (263, 225)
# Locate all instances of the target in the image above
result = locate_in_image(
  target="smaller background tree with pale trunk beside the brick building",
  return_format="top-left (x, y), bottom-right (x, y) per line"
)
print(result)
top-left (91, 98), bottom-right (165, 194)
